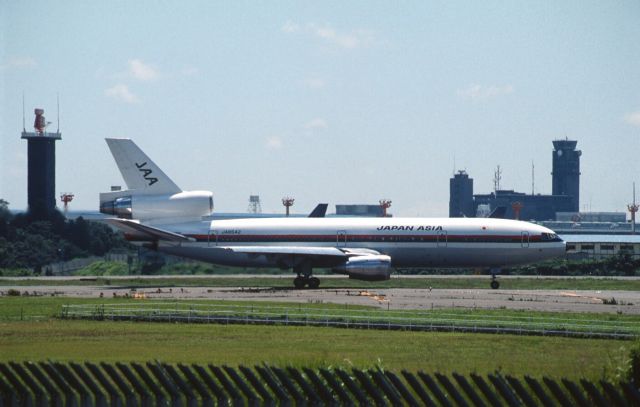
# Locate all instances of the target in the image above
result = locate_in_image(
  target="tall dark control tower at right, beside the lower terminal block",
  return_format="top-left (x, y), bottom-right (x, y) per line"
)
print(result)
top-left (551, 140), bottom-right (582, 212)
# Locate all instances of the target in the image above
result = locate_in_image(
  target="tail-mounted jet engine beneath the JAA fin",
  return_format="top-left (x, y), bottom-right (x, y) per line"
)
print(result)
top-left (100, 191), bottom-right (213, 220)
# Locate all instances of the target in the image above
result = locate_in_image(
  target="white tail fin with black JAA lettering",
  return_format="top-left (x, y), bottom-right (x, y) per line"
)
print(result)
top-left (105, 138), bottom-right (182, 194)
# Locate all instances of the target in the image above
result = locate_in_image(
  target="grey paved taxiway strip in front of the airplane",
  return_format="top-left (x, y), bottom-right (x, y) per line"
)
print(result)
top-left (0, 276), bottom-right (640, 314)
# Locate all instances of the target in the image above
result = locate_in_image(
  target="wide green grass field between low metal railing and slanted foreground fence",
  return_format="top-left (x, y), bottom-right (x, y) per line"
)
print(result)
top-left (0, 297), bottom-right (635, 379)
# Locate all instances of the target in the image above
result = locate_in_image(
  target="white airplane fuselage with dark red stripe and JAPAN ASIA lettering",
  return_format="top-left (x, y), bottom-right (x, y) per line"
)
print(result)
top-left (141, 217), bottom-right (565, 268)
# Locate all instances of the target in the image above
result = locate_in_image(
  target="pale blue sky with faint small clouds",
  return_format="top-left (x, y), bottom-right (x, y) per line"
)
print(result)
top-left (0, 0), bottom-right (640, 216)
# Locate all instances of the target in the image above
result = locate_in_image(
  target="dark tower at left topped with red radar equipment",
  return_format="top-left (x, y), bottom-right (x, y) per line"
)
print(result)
top-left (22, 109), bottom-right (62, 219)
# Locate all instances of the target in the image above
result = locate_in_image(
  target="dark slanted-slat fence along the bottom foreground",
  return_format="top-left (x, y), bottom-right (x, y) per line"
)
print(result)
top-left (0, 361), bottom-right (640, 406)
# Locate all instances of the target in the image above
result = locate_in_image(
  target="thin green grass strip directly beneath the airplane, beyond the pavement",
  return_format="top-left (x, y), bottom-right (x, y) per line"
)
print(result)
top-left (0, 274), bottom-right (640, 291)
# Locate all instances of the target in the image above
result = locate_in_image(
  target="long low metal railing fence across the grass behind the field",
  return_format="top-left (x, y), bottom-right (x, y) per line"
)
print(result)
top-left (61, 302), bottom-right (640, 339)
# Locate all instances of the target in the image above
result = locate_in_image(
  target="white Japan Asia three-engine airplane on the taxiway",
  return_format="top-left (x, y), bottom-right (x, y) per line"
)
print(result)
top-left (100, 139), bottom-right (565, 289)
